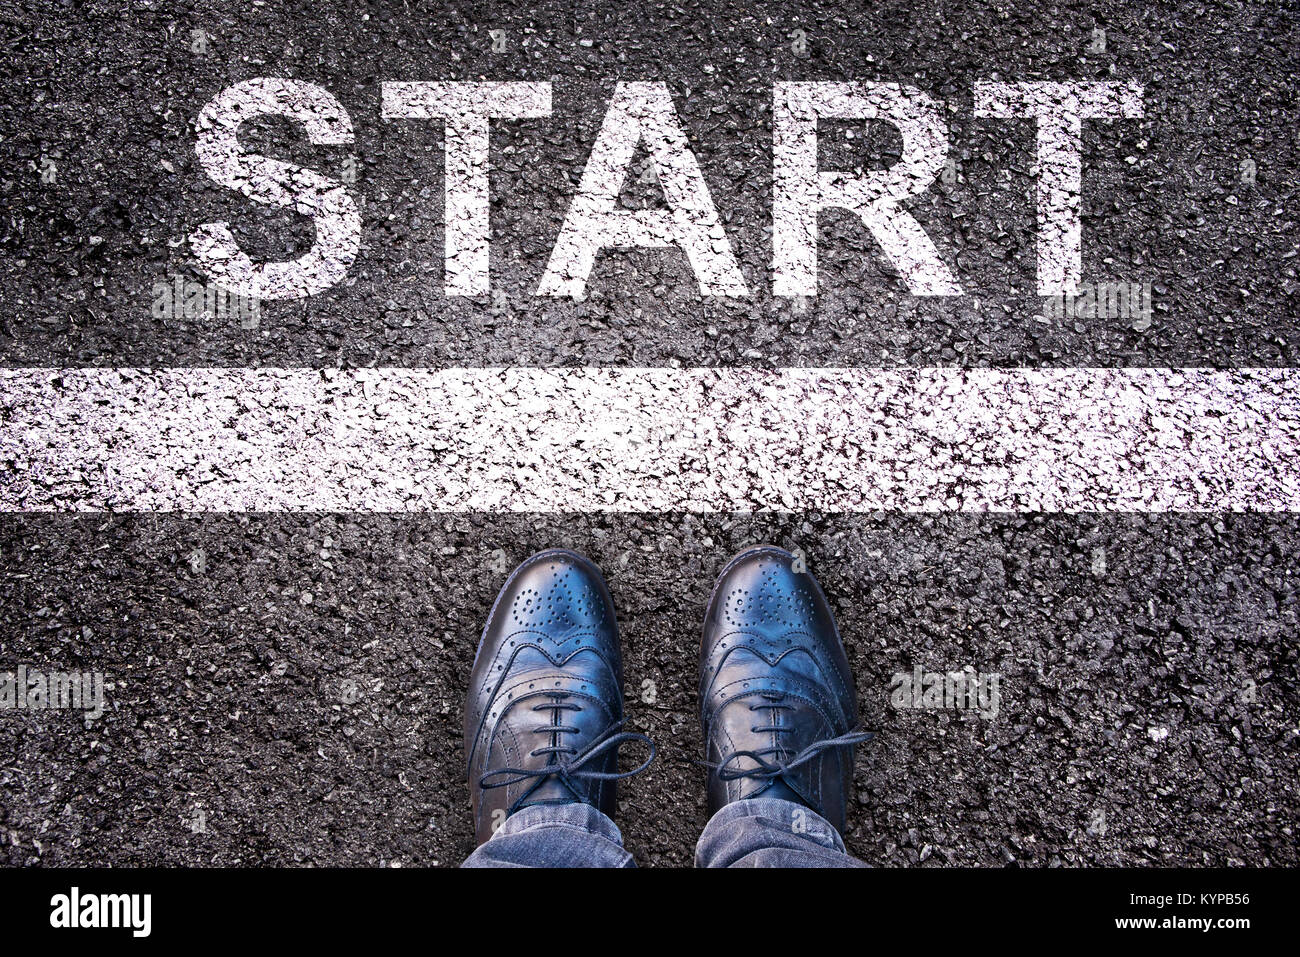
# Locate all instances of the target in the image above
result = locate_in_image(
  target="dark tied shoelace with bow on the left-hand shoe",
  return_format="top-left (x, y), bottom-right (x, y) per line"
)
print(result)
top-left (478, 692), bottom-right (655, 814)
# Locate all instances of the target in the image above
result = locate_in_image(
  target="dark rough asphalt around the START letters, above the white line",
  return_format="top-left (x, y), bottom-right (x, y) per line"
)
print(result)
top-left (0, 0), bottom-right (1300, 367)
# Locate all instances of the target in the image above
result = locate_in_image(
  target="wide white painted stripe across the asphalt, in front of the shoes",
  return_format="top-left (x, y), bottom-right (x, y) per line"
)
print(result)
top-left (0, 368), bottom-right (1300, 512)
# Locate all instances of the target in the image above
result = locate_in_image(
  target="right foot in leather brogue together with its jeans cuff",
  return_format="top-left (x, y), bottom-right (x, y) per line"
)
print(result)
top-left (696, 546), bottom-right (871, 867)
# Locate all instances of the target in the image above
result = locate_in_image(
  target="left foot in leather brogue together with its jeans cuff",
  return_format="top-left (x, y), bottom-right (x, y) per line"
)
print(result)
top-left (465, 549), bottom-right (654, 867)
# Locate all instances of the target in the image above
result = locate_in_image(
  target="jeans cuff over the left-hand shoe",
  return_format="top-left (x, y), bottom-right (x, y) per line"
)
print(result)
top-left (462, 804), bottom-right (636, 867)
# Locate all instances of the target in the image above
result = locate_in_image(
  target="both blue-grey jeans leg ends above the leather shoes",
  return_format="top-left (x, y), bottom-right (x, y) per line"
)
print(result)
top-left (463, 797), bottom-right (866, 867)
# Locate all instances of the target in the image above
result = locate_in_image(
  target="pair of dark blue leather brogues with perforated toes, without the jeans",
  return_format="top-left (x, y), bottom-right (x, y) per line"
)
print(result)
top-left (465, 546), bottom-right (871, 844)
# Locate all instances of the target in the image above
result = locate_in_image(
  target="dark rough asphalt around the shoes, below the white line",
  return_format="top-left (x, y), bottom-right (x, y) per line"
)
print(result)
top-left (0, 515), bottom-right (1300, 866)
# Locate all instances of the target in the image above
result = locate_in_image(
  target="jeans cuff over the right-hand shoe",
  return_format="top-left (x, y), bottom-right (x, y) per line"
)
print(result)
top-left (696, 797), bottom-right (866, 867)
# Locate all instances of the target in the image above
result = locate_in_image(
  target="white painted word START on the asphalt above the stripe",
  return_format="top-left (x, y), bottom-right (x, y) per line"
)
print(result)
top-left (191, 77), bottom-right (1143, 299)
